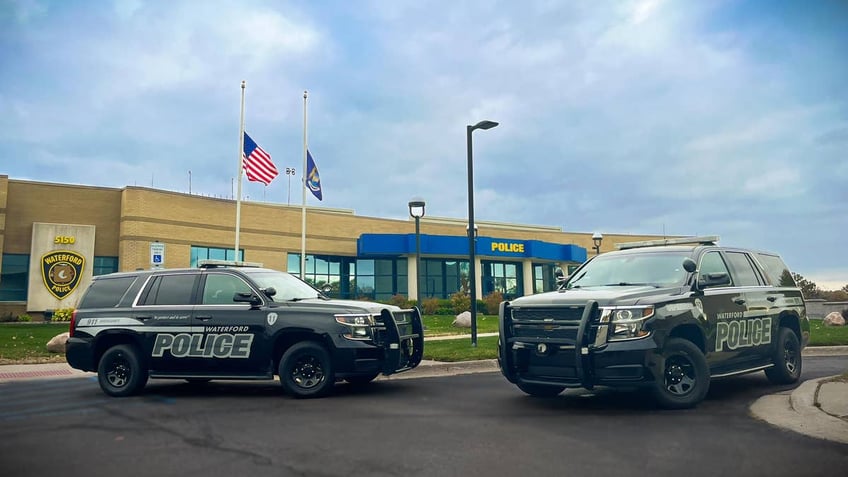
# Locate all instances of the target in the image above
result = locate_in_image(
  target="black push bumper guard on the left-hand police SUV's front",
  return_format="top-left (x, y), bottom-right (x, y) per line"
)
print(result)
top-left (380, 307), bottom-right (424, 375)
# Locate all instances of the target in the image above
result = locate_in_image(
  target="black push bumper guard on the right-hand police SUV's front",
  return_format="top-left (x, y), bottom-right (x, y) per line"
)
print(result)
top-left (498, 300), bottom-right (609, 389)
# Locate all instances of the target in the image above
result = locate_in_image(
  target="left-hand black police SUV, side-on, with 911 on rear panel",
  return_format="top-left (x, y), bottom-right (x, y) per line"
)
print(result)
top-left (65, 261), bottom-right (424, 398)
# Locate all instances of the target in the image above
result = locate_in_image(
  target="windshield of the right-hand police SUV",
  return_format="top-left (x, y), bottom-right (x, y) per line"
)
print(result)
top-left (565, 252), bottom-right (688, 289)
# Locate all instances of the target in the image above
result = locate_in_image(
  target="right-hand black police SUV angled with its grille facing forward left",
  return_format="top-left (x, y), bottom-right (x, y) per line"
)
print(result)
top-left (498, 236), bottom-right (810, 409)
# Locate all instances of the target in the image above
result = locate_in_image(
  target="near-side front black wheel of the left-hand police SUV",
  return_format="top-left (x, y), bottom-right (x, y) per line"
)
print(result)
top-left (279, 341), bottom-right (335, 398)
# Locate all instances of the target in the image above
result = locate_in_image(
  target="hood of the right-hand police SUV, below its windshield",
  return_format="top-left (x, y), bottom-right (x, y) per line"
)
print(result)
top-left (510, 285), bottom-right (688, 306)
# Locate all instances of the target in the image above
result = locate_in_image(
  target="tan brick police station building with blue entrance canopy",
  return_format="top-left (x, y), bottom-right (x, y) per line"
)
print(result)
top-left (0, 175), bottom-right (661, 317)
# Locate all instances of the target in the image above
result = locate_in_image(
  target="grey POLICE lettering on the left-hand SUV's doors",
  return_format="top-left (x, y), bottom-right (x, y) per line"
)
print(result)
top-left (153, 333), bottom-right (253, 358)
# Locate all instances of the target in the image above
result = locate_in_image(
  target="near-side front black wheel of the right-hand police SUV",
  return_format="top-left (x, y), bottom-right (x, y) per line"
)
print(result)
top-left (653, 338), bottom-right (710, 409)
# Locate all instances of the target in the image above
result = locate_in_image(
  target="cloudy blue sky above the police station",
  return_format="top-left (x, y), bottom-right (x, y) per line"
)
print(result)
top-left (0, 0), bottom-right (848, 289)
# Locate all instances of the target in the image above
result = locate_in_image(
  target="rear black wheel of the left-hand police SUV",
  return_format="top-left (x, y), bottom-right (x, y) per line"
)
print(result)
top-left (97, 345), bottom-right (147, 397)
